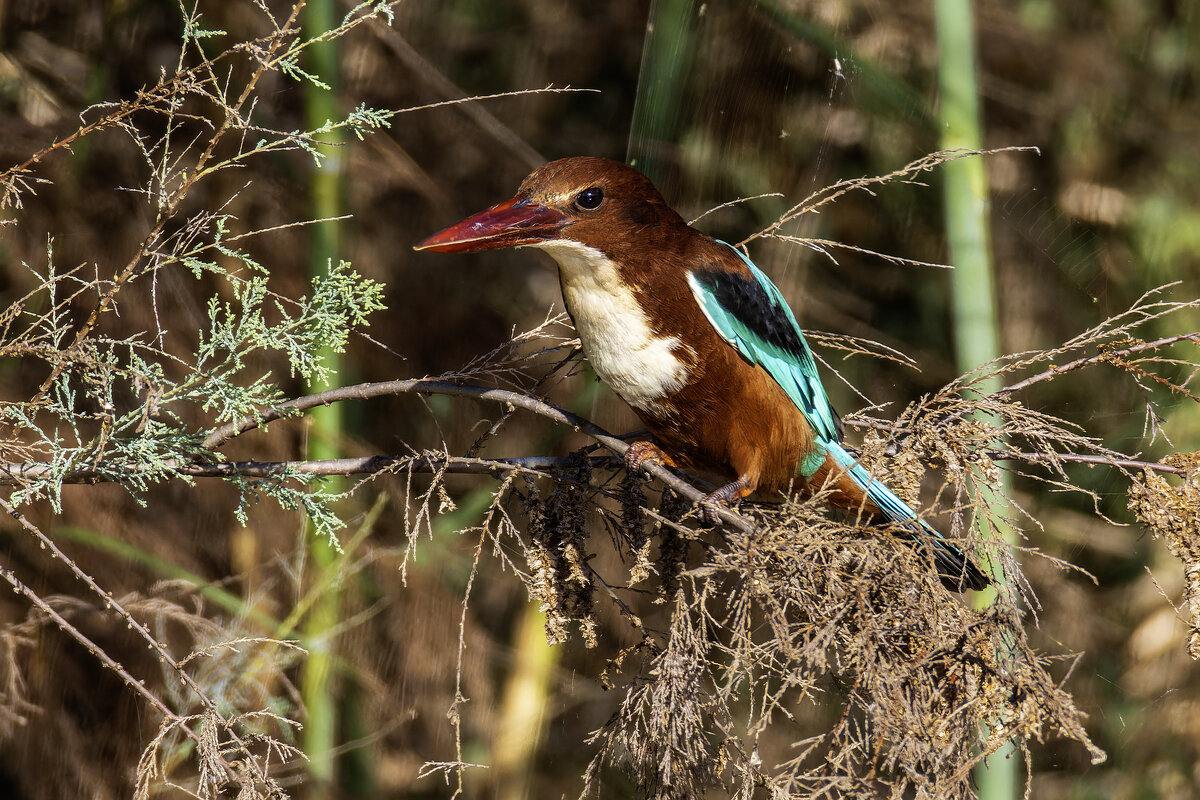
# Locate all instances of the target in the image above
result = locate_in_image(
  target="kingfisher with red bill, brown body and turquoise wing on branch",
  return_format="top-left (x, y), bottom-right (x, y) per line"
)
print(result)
top-left (414, 156), bottom-right (990, 591)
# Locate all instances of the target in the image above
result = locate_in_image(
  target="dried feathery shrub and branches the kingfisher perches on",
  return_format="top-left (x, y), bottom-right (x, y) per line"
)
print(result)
top-left (0, 2), bottom-right (1200, 798)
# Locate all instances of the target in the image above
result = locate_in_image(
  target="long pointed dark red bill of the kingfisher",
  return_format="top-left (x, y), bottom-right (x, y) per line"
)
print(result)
top-left (413, 197), bottom-right (570, 253)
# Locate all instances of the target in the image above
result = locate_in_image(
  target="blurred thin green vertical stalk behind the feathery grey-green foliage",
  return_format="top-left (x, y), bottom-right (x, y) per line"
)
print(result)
top-left (300, 0), bottom-right (343, 796)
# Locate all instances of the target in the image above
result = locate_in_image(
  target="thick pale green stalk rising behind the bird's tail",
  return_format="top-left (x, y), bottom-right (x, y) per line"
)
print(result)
top-left (934, 0), bottom-right (1018, 800)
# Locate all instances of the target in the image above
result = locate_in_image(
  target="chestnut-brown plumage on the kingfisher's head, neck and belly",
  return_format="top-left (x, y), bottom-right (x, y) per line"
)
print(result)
top-left (517, 158), bottom-right (811, 504)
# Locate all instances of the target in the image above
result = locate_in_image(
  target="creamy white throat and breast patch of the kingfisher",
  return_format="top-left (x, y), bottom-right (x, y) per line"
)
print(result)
top-left (533, 240), bottom-right (695, 413)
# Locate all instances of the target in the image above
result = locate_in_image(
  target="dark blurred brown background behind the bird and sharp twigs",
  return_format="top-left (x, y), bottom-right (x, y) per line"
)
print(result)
top-left (0, 0), bottom-right (1200, 799)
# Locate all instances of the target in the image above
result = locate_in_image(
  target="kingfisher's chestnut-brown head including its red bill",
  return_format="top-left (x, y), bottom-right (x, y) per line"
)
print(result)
top-left (414, 157), bottom-right (685, 255)
